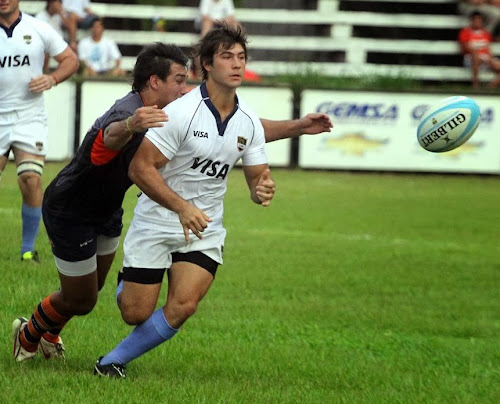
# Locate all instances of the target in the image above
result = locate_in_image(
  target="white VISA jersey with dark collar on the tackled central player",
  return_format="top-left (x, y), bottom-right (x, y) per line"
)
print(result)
top-left (135, 84), bottom-right (267, 230)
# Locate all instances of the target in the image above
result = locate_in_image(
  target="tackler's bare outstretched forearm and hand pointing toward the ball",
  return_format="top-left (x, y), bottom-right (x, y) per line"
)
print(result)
top-left (260, 113), bottom-right (333, 143)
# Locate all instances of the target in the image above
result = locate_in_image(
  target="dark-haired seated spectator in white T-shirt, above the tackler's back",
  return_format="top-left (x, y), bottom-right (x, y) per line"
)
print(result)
top-left (78, 18), bottom-right (125, 77)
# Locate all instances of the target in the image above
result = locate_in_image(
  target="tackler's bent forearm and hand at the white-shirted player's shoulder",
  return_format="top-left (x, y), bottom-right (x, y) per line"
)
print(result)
top-left (104, 105), bottom-right (168, 150)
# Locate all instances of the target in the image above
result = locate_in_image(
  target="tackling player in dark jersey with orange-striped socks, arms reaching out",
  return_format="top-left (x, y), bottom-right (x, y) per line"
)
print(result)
top-left (12, 43), bottom-right (332, 362)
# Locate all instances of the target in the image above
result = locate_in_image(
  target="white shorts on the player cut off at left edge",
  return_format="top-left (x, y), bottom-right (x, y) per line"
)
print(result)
top-left (0, 111), bottom-right (49, 156)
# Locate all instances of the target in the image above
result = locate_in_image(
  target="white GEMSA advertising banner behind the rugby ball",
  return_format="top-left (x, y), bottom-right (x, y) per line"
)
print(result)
top-left (299, 90), bottom-right (500, 173)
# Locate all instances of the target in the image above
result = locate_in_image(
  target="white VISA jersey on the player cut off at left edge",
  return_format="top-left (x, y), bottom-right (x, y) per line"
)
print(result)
top-left (0, 13), bottom-right (68, 114)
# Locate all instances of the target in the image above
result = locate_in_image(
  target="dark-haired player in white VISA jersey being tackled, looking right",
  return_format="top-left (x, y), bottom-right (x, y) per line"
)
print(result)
top-left (94, 23), bottom-right (275, 378)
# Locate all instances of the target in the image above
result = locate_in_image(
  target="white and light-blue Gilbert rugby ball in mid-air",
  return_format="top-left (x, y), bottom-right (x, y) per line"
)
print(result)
top-left (417, 96), bottom-right (481, 153)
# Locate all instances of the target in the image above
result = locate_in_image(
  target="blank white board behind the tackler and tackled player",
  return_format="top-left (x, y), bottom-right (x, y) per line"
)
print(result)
top-left (80, 81), bottom-right (293, 166)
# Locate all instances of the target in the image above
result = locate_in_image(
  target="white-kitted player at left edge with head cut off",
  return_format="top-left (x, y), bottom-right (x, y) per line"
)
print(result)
top-left (0, 0), bottom-right (78, 261)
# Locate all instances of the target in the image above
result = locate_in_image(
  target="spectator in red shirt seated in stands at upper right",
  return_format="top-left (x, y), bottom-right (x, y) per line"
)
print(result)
top-left (458, 11), bottom-right (500, 88)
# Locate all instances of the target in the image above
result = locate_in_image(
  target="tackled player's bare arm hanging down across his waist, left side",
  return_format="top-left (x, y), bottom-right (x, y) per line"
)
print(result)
top-left (128, 138), bottom-right (211, 242)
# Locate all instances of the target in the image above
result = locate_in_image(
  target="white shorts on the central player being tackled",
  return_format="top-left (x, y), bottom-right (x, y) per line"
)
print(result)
top-left (123, 218), bottom-right (226, 269)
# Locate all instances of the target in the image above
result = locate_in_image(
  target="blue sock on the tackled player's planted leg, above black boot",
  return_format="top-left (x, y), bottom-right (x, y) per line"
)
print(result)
top-left (101, 308), bottom-right (178, 365)
